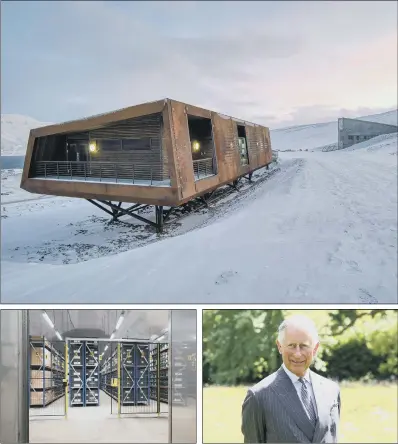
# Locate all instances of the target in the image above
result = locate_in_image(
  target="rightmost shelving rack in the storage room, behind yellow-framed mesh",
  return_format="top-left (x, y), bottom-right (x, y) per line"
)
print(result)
top-left (150, 343), bottom-right (169, 403)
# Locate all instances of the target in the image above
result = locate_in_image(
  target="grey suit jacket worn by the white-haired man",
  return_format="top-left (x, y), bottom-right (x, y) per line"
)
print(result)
top-left (242, 367), bottom-right (341, 443)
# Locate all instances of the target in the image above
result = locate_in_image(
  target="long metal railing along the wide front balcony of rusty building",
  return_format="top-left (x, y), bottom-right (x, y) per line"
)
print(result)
top-left (33, 161), bottom-right (170, 185)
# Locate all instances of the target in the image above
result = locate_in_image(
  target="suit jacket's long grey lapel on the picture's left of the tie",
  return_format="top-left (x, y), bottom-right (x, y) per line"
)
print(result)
top-left (271, 367), bottom-right (314, 442)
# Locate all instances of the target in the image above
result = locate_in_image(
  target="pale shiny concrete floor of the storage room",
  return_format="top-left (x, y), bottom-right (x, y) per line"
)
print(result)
top-left (29, 391), bottom-right (168, 443)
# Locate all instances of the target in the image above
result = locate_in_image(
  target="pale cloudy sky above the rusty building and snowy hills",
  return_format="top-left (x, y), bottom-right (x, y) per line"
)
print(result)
top-left (1, 1), bottom-right (397, 128)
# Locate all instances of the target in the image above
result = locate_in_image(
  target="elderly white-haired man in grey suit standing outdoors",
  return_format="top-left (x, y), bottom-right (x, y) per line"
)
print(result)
top-left (242, 315), bottom-right (340, 443)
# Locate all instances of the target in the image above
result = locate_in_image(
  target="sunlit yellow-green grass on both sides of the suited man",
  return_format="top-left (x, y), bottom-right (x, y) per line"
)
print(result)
top-left (203, 383), bottom-right (398, 443)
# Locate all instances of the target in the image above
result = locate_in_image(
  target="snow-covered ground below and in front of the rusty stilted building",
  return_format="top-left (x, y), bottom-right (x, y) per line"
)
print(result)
top-left (1, 137), bottom-right (397, 303)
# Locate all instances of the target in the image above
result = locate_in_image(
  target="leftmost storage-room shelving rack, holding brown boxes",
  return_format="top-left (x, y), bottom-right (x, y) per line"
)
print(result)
top-left (29, 336), bottom-right (65, 407)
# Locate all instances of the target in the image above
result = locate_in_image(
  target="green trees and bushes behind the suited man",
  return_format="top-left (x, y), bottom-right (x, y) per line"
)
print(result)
top-left (203, 309), bottom-right (398, 385)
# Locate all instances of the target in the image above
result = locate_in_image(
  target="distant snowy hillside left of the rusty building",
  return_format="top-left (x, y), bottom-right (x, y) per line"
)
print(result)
top-left (1, 114), bottom-right (51, 156)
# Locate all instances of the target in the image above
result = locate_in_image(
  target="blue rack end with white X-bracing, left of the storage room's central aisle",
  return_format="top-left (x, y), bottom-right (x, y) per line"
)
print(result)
top-left (69, 340), bottom-right (100, 407)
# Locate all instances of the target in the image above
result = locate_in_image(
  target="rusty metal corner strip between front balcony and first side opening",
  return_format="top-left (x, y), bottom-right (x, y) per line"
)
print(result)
top-left (169, 100), bottom-right (195, 198)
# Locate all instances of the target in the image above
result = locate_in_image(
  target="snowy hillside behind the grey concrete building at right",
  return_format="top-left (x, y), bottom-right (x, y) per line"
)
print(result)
top-left (271, 110), bottom-right (398, 151)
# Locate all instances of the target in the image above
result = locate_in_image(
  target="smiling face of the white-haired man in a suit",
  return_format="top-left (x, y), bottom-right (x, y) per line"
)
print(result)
top-left (276, 325), bottom-right (319, 377)
